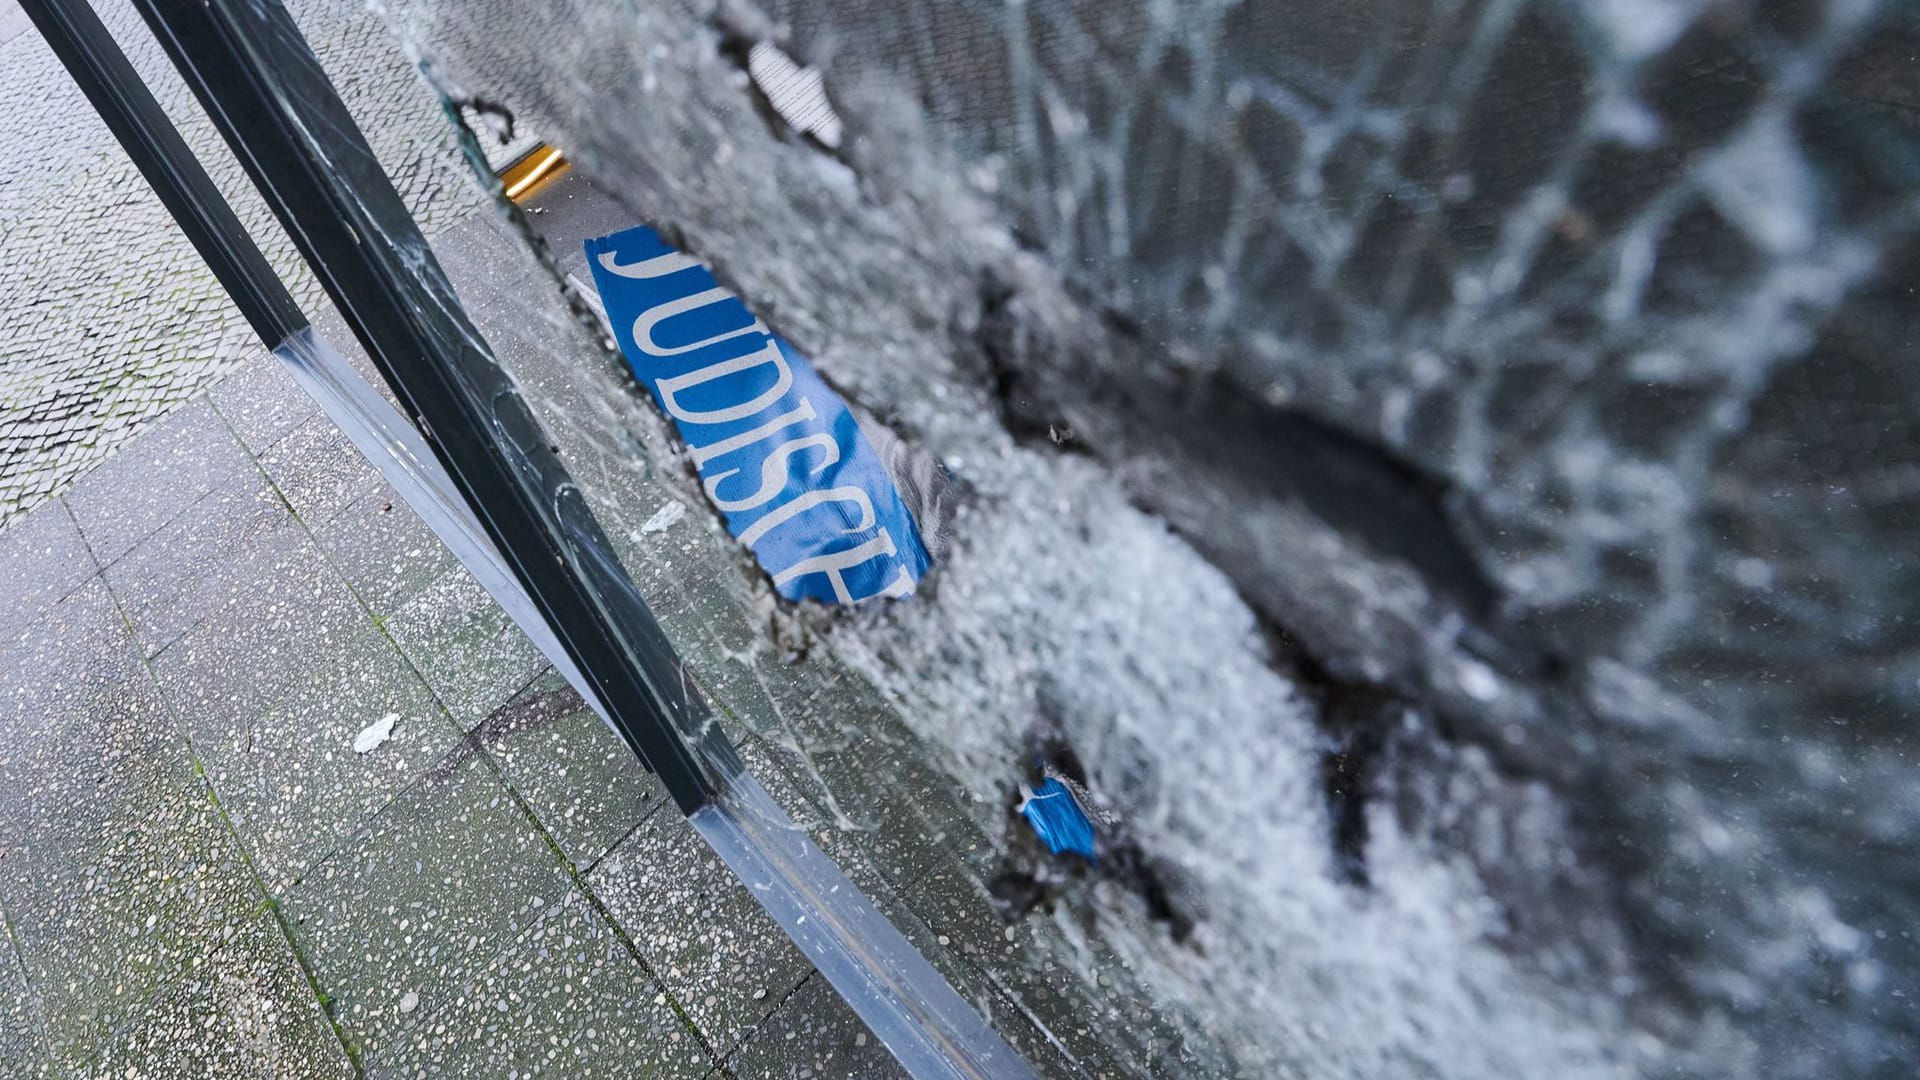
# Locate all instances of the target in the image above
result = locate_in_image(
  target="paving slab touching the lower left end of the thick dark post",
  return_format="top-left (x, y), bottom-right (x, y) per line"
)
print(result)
top-left (472, 671), bottom-right (678, 871)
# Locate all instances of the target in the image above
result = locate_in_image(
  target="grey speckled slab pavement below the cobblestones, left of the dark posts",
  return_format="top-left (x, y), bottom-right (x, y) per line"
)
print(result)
top-left (0, 320), bottom-right (1121, 1078)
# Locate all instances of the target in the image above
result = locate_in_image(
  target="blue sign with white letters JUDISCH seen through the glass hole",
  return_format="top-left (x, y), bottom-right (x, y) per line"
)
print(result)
top-left (586, 227), bottom-right (931, 603)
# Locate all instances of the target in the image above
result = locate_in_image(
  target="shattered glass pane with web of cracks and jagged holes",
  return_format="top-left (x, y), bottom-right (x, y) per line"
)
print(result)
top-left (307, 0), bottom-right (1920, 1078)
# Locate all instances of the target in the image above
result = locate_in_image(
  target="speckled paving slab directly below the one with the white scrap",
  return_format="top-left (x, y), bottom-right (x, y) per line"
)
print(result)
top-left (282, 737), bottom-right (572, 1061)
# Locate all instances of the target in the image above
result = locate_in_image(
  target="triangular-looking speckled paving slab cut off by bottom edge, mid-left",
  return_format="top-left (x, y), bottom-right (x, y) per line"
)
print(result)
top-left (367, 890), bottom-right (712, 1080)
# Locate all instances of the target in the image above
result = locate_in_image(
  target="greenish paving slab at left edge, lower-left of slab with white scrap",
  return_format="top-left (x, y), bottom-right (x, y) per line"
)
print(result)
top-left (0, 675), bottom-right (261, 1067)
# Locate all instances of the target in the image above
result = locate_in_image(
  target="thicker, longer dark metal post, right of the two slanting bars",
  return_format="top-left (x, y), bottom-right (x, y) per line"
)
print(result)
top-left (118, 0), bottom-right (739, 813)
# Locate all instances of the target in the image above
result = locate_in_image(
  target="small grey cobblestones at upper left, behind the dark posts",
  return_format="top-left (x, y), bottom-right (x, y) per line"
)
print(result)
top-left (0, 0), bottom-right (480, 523)
